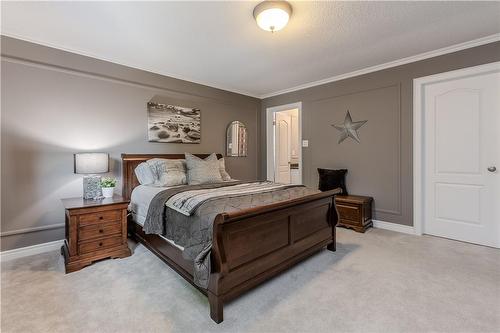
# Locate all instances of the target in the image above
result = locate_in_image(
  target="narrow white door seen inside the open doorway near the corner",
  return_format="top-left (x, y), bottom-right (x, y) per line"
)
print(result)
top-left (274, 112), bottom-right (292, 184)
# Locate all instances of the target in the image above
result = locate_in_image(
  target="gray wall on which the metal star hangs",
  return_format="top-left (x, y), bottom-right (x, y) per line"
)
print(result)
top-left (261, 42), bottom-right (500, 225)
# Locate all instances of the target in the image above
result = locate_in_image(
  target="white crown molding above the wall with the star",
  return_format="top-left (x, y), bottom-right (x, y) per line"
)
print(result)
top-left (259, 33), bottom-right (500, 99)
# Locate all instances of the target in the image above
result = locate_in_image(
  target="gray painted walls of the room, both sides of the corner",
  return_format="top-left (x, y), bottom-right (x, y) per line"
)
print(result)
top-left (1, 37), bottom-right (500, 250)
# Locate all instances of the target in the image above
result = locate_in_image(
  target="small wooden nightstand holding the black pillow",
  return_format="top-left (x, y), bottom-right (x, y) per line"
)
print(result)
top-left (335, 195), bottom-right (373, 232)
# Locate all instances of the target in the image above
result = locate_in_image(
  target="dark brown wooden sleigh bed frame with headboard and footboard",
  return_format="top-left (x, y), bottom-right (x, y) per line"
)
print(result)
top-left (122, 154), bottom-right (340, 323)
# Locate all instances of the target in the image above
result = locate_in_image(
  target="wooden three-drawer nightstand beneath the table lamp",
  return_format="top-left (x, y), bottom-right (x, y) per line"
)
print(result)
top-left (61, 196), bottom-right (130, 273)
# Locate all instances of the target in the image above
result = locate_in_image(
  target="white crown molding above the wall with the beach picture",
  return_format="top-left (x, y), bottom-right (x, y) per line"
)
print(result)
top-left (1, 31), bottom-right (259, 98)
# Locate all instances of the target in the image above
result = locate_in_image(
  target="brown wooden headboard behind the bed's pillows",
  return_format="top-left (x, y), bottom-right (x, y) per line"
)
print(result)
top-left (122, 154), bottom-right (222, 200)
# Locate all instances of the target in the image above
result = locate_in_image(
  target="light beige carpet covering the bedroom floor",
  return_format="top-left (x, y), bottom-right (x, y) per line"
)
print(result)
top-left (1, 229), bottom-right (500, 333)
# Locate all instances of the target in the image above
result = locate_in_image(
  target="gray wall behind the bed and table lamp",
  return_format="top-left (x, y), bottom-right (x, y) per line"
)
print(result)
top-left (1, 37), bottom-right (261, 250)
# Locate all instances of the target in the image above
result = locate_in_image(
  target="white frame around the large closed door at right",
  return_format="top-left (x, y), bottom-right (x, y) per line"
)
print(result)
top-left (413, 61), bottom-right (500, 235)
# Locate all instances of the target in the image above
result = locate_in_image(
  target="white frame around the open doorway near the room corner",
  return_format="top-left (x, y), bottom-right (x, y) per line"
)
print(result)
top-left (266, 102), bottom-right (304, 184)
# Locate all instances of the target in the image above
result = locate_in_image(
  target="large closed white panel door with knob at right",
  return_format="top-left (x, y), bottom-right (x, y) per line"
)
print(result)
top-left (422, 66), bottom-right (500, 247)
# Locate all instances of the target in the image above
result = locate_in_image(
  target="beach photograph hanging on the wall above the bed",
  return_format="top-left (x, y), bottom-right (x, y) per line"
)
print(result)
top-left (148, 102), bottom-right (201, 143)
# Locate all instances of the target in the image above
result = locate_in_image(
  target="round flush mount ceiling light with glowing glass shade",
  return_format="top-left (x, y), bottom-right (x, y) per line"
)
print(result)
top-left (253, 1), bottom-right (292, 32)
